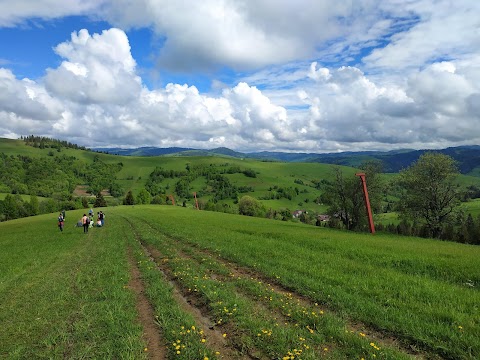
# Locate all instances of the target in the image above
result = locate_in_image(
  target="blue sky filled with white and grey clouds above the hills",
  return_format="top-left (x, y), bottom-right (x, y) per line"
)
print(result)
top-left (0, 0), bottom-right (480, 153)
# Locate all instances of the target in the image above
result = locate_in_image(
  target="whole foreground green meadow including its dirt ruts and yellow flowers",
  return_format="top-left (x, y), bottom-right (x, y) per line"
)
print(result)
top-left (0, 206), bottom-right (480, 360)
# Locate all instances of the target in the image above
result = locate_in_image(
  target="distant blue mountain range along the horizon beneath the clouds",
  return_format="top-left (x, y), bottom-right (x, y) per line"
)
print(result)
top-left (93, 145), bottom-right (480, 176)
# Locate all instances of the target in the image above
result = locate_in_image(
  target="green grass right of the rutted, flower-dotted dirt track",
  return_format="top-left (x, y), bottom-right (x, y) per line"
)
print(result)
top-left (125, 207), bottom-right (480, 358)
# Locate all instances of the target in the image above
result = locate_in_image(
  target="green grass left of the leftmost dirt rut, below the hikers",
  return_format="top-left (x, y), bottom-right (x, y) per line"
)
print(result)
top-left (0, 211), bottom-right (144, 359)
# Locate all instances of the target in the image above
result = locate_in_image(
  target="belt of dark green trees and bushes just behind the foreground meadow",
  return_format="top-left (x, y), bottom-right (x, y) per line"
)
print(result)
top-left (0, 135), bottom-right (480, 244)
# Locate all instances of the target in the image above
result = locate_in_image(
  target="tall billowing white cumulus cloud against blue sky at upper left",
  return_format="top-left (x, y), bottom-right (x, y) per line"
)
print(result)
top-left (45, 28), bottom-right (141, 103)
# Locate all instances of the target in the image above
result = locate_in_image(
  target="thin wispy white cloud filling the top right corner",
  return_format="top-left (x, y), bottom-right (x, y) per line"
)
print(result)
top-left (363, 0), bottom-right (480, 69)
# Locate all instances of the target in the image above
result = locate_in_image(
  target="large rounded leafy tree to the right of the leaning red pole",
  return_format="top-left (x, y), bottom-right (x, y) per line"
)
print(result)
top-left (399, 152), bottom-right (460, 238)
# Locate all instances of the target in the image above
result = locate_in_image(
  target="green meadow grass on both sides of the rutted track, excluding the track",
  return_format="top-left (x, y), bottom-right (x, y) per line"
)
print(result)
top-left (0, 206), bottom-right (480, 359)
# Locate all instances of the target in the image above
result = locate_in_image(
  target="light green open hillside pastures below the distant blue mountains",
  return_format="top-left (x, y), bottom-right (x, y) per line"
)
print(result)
top-left (0, 139), bottom-right (346, 213)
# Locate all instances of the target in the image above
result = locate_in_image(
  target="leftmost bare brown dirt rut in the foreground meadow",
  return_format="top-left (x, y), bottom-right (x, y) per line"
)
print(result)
top-left (128, 249), bottom-right (167, 360)
